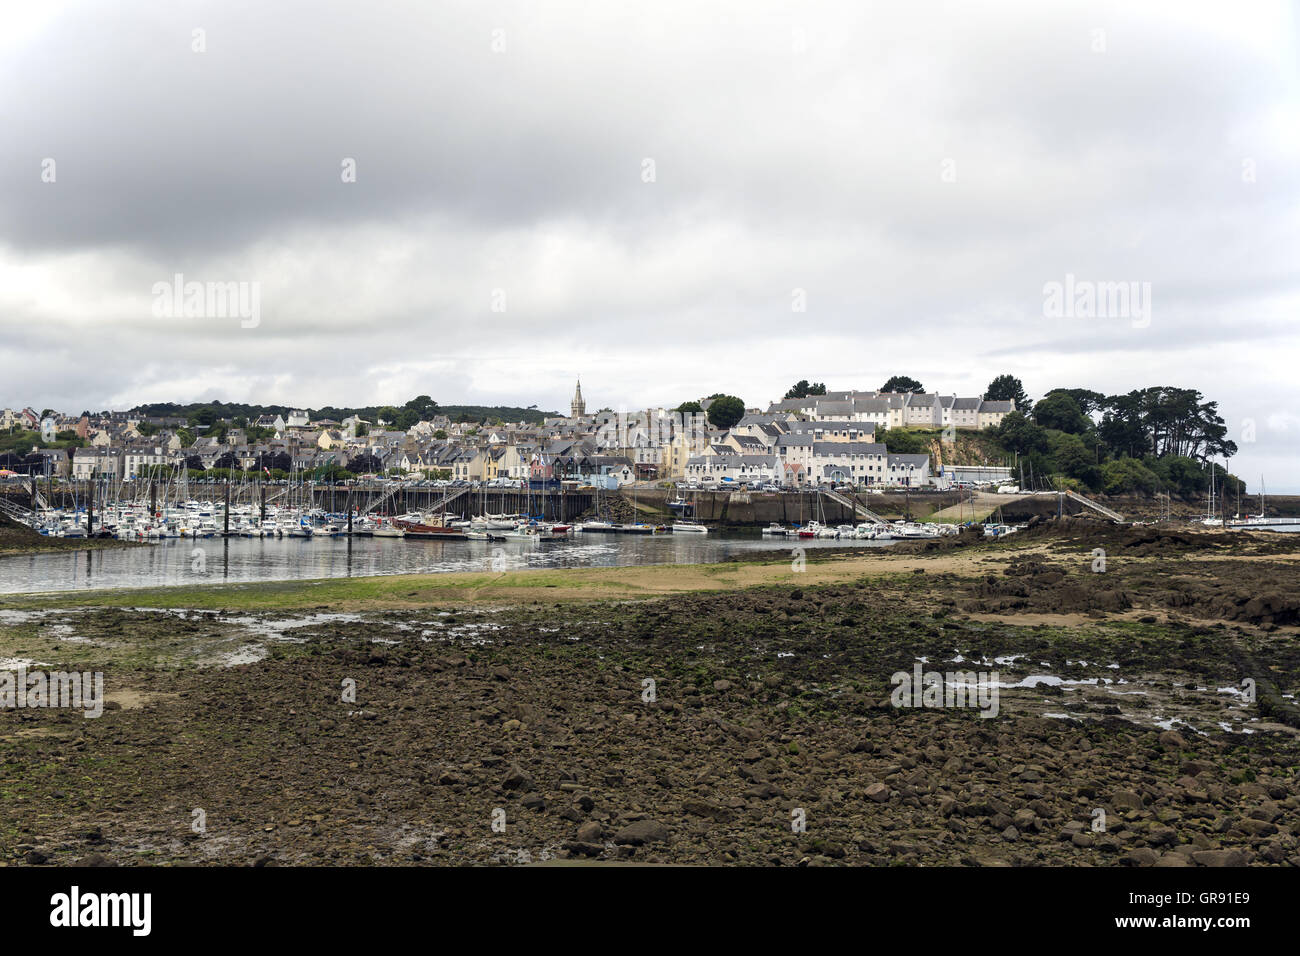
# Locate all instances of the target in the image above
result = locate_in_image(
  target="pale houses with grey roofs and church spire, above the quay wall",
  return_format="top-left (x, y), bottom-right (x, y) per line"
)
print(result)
top-left (0, 382), bottom-right (1015, 488)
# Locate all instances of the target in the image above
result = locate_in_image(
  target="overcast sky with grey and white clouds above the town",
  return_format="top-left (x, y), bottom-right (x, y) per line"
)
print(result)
top-left (0, 0), bottom-right (1300, 492)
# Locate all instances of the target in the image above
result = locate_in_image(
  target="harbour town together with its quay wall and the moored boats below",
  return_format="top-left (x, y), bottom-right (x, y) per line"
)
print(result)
top-left (0, 382), bottom-right (1284, 556)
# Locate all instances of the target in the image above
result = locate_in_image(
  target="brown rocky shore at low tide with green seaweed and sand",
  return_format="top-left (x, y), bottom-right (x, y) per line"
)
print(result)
top-left (0, 523), bottom-right (1300, 866)
